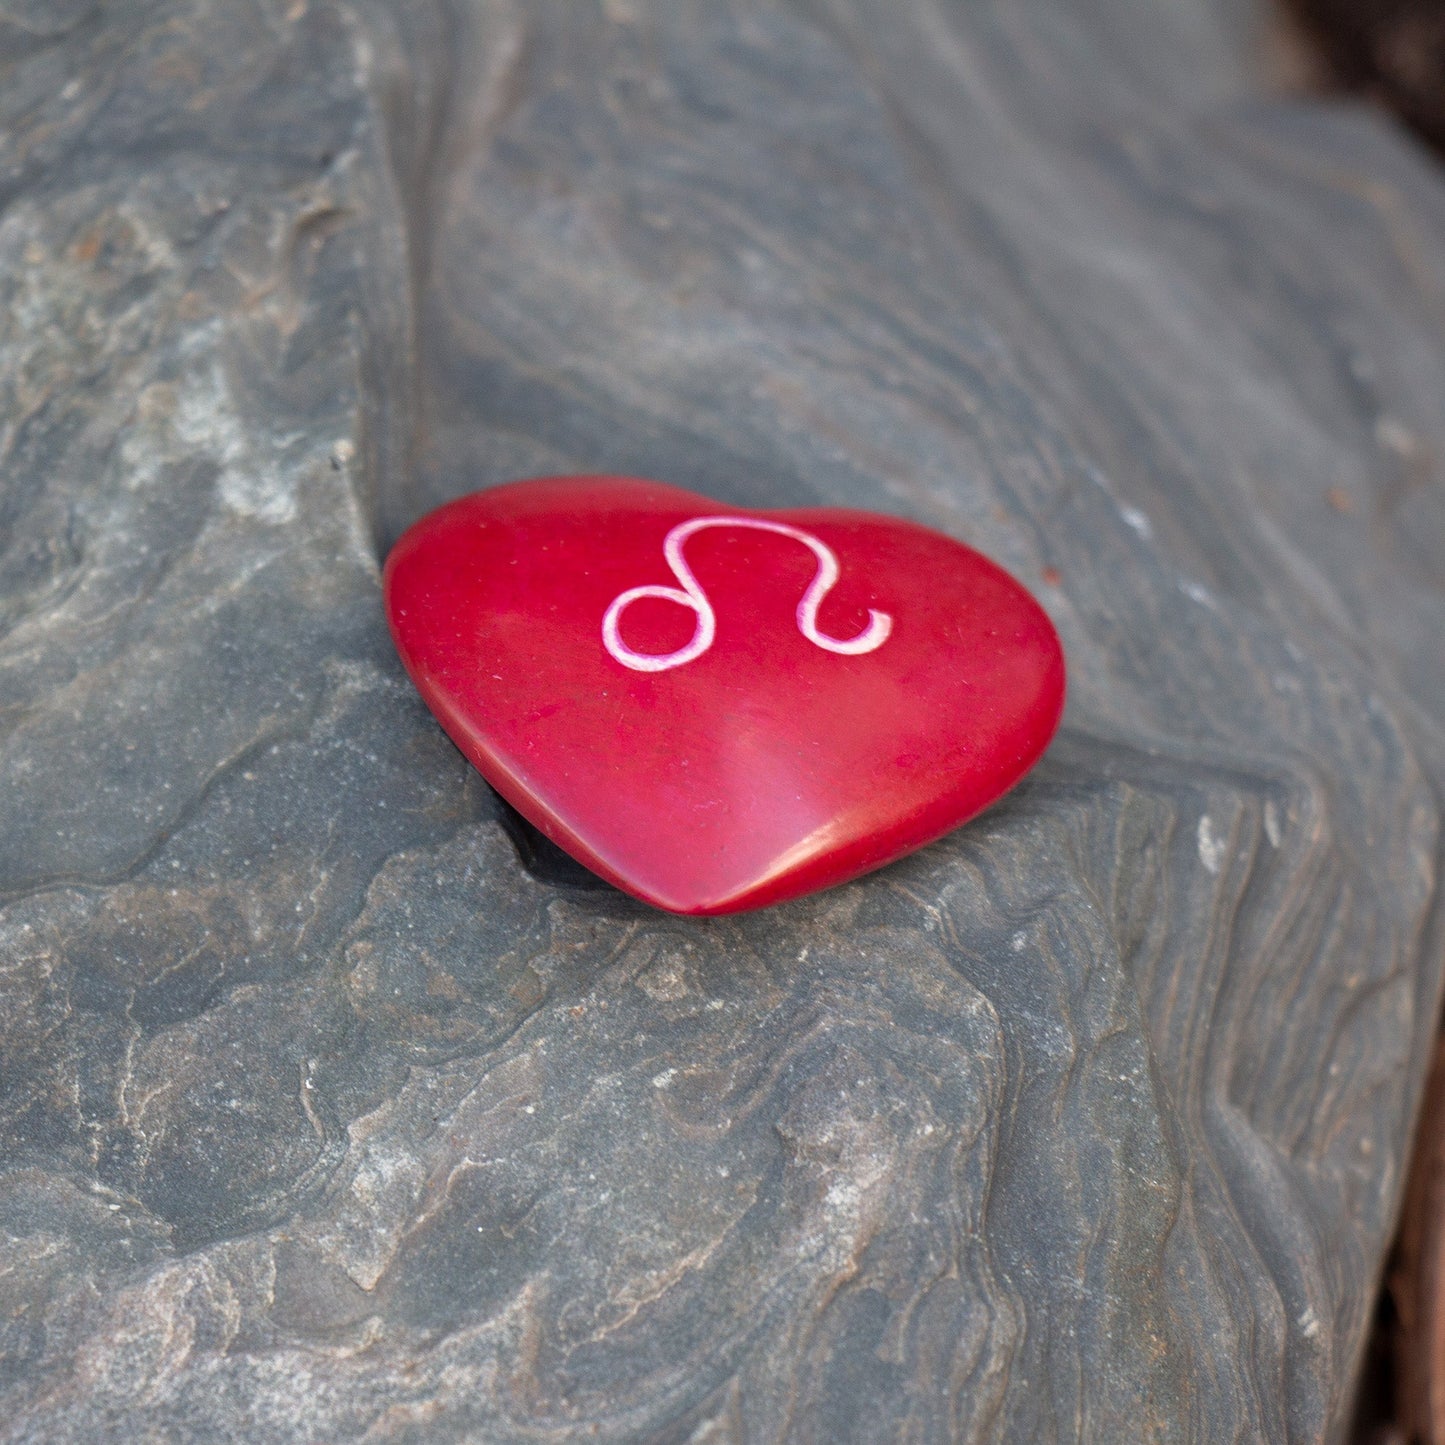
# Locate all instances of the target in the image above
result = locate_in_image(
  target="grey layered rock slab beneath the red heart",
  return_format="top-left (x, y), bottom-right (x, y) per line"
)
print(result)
top-left (0, 0), bottom-right (1445, 1445)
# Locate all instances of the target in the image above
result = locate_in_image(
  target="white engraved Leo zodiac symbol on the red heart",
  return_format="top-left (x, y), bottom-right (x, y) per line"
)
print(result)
top-left (603, 517), bottom-right (893, 672)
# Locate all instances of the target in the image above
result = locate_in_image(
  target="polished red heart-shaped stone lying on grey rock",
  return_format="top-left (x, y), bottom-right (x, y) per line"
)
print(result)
top-left (384, 477), bottom-right (1064, 913)
